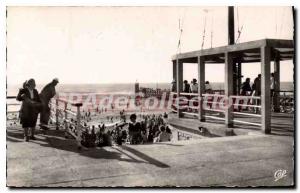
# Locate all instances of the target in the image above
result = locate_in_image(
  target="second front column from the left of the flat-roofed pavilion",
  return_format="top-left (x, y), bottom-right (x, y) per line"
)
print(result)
top-left (198, 56), bottom-right (205, 121)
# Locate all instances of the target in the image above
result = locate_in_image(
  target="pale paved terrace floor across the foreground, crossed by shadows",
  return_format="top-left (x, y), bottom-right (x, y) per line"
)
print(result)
top-left (7, 119), bottom-right (294, 187)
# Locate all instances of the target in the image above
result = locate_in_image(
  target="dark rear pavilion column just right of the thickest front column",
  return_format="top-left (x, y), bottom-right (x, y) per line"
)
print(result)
top-left (273, 57), bottom-right (280, 112)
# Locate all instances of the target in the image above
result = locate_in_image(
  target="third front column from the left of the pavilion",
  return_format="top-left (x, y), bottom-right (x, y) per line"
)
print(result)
top-left (224, 52), bottom-right (233, 127)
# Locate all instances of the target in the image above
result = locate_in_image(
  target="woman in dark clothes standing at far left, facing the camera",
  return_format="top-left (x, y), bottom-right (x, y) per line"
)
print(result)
top-left (17, 79), bottom-right (41, 141)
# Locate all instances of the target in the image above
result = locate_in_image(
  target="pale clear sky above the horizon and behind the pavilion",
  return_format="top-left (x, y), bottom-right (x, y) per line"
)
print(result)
top-left (6, 6), bottom-right (293, 84)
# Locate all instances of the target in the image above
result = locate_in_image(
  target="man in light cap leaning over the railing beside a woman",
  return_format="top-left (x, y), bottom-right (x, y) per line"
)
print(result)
top-left (40, 78), bottom-right (58, 129)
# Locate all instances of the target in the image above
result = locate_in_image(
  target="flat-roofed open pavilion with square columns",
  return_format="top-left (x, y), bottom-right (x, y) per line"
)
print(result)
top-left (172, 39), bottom-right (294, 134)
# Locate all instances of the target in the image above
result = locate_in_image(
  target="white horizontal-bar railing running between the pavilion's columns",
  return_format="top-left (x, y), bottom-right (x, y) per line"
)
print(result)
top-left (172, 91), bottom-right (294, 130)
